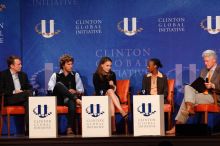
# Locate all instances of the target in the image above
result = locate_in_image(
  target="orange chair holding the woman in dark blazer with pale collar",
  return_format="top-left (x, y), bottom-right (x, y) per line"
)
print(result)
top-left (164, 79), bottom-right (175, 129)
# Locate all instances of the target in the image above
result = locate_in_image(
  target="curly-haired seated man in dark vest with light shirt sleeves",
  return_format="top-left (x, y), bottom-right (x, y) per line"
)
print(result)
top-left (48, 54), bottom-right (84, 135)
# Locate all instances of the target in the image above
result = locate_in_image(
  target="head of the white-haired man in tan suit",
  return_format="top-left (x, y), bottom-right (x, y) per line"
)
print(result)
top-left (202, 50), bottom-right (217, 69)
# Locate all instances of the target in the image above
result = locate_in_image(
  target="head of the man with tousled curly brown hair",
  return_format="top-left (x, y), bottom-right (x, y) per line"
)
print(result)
top-left (60, 54), bottom-right (74, 72)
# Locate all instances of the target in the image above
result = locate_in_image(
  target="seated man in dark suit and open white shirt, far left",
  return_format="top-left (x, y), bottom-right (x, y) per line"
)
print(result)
top-left (0, 56), bottom-right (32, 134)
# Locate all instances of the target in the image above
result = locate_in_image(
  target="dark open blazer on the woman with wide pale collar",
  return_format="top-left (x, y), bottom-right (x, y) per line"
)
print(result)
top-left (142, 74), bottom-right (168, 103)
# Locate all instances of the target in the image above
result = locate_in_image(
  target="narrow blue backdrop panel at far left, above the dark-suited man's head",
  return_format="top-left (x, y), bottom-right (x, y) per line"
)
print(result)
top-left (0, 0), bottom-right (22, 70)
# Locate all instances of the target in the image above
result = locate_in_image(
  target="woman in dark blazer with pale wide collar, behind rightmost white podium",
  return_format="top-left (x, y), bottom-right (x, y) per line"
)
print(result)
top-left (142, 58), bottom-right (168, 103)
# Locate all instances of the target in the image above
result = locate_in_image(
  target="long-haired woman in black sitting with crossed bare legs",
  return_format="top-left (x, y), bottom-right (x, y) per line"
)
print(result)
top-left (93, 57), bottom-right (127, 133)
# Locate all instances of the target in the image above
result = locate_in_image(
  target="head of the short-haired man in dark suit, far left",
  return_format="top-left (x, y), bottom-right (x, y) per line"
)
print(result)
top-left (7, 55), bottom-right (22, 73)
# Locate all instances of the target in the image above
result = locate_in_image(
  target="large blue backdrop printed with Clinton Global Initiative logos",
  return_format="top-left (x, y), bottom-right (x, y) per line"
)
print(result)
top-left (0, 0), bottom-right (220, 135)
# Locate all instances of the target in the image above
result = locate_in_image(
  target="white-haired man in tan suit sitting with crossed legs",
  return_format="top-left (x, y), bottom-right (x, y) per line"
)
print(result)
top-left (166, 50), bottom-right (220, 134)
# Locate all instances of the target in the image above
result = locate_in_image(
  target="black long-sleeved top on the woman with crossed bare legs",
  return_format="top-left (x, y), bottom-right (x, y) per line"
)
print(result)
top-left (93, 71), bottom-right (116, 95)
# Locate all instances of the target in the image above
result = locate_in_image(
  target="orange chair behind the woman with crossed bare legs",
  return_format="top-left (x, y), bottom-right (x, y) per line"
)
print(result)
top-left (115, 80), bottom-right (130, 134)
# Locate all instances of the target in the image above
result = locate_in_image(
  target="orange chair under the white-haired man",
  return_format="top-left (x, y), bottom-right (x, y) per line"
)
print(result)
top-left (194, 90), bottom-right (220, 124)
